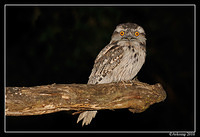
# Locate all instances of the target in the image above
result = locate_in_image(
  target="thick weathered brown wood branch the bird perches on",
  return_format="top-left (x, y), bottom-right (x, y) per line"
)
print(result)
top-left (5, 80), bottom-right (166, 116)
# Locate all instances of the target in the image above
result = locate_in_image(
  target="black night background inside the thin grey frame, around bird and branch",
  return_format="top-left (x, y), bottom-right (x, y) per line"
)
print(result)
top-left (6, 6), bottom-right (194, 131)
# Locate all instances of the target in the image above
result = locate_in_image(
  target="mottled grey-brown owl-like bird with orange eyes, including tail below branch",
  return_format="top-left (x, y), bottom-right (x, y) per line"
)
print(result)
top-left (77, 23), bottom-right (146, 126)
